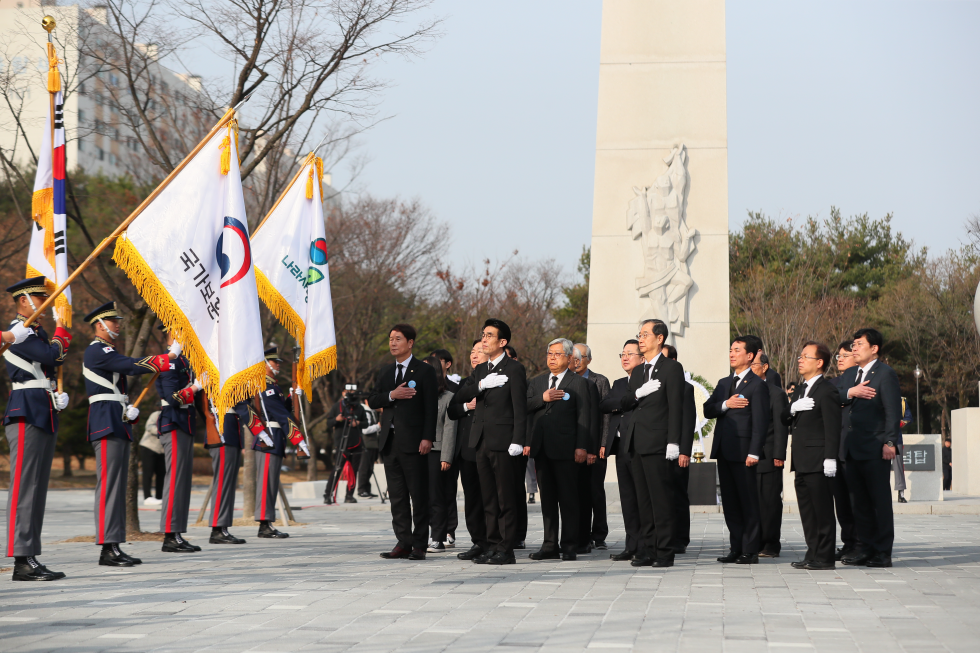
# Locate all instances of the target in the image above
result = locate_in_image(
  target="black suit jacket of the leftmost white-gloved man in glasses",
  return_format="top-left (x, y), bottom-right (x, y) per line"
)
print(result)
top-left (453, 354), bottom-right (527, 451)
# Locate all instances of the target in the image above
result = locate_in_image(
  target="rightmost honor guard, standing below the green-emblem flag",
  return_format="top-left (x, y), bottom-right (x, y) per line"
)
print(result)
top-left (253, 346), bottom-right (310, 538)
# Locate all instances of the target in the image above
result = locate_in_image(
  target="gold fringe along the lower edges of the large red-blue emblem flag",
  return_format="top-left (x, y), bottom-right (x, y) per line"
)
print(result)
top-left (112, 232), bottom-right (265, 415)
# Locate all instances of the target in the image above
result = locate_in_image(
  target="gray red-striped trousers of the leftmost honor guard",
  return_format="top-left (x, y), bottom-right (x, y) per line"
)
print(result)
top-left (4, 422), bottom-right (56, 558)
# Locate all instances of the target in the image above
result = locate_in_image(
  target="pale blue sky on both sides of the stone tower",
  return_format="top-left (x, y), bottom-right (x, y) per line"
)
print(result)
top-left (334, 0), bottom-right (980, 272)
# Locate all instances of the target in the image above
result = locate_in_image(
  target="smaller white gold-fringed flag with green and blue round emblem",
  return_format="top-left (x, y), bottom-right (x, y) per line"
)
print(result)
top-left (252, 151), bottom-right (337, 397)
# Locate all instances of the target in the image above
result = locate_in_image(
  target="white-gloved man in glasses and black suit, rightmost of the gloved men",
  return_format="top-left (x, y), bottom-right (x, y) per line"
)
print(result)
top-left (780, 340), bottom-right (841, 570)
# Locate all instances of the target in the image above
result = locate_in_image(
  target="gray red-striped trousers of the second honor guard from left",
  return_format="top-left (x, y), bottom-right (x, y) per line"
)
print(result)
top-left (92, 438), bottom-right (132, 544)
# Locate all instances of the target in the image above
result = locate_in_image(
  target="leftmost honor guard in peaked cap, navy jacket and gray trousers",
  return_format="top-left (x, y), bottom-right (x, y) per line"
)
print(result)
top-left (3, 277), bottom-right (71, 580)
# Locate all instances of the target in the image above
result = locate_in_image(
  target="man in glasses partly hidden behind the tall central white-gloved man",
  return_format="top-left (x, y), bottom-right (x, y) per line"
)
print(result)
top-left (599, 339), bottom-right (643, 561)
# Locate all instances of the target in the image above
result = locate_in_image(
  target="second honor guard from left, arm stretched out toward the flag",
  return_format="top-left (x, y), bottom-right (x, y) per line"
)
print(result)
top-left (82, 302), bottom-right (180, 567)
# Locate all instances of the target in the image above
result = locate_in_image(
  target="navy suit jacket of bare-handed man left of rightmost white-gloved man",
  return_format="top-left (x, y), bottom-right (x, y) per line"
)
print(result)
top-left (704, 370), bottom-right (772, 462)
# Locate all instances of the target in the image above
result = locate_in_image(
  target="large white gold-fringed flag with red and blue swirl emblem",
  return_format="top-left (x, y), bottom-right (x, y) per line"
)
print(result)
top-left (112, 112), bottom-right (265, 414)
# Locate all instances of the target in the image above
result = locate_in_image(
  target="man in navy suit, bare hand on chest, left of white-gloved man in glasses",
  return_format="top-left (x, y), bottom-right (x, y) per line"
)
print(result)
top-left (704, 336), bottom-right (772, 565)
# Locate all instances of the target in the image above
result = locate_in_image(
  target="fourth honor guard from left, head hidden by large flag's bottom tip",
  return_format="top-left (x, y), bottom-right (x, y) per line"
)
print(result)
top-left (208, 399), bottom-right (264, 544)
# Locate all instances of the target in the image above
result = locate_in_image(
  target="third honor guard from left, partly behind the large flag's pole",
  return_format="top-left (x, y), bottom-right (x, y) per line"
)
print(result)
top-left (156, 325), bottom-right (201, 553)
